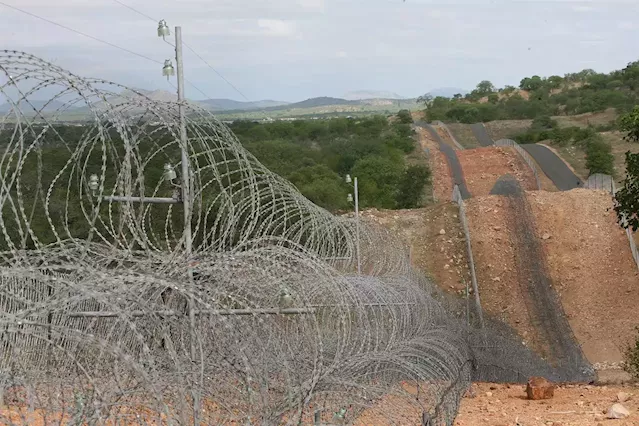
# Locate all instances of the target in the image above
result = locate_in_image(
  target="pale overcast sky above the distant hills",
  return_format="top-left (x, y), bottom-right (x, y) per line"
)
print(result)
top-left (0, 0), bottom-right (640, 101)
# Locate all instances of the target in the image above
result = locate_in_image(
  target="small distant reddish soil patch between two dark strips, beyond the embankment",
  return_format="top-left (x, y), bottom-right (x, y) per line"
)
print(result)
top-left (458, 147), bottom-right (538, 197)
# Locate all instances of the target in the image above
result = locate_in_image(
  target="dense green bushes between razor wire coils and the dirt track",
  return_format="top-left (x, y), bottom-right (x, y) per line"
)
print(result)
top-left (230, 115), bottom-right (431, 210)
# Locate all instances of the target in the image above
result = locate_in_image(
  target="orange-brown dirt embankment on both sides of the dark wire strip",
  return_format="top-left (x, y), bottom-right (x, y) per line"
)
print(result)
top-left (467, 189), bottom-right (640, 364)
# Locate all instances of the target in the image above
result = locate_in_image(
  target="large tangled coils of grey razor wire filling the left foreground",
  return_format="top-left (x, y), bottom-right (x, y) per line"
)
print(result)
top-left (0, 51), bottom-right (588, 425)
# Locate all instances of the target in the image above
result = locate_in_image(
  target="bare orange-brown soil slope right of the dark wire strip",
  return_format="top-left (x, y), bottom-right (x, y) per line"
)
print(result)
top-left (529, 189), bottom-right (640, 363)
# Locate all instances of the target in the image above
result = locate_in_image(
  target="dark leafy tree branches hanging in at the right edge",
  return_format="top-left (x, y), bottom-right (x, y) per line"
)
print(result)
top-left (615, 108), bottom-right (640, 231)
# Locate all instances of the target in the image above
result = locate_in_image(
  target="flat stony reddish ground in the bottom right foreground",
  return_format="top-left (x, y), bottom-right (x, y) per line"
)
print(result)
top-left (456, 383), bottom-right (640, 426)
